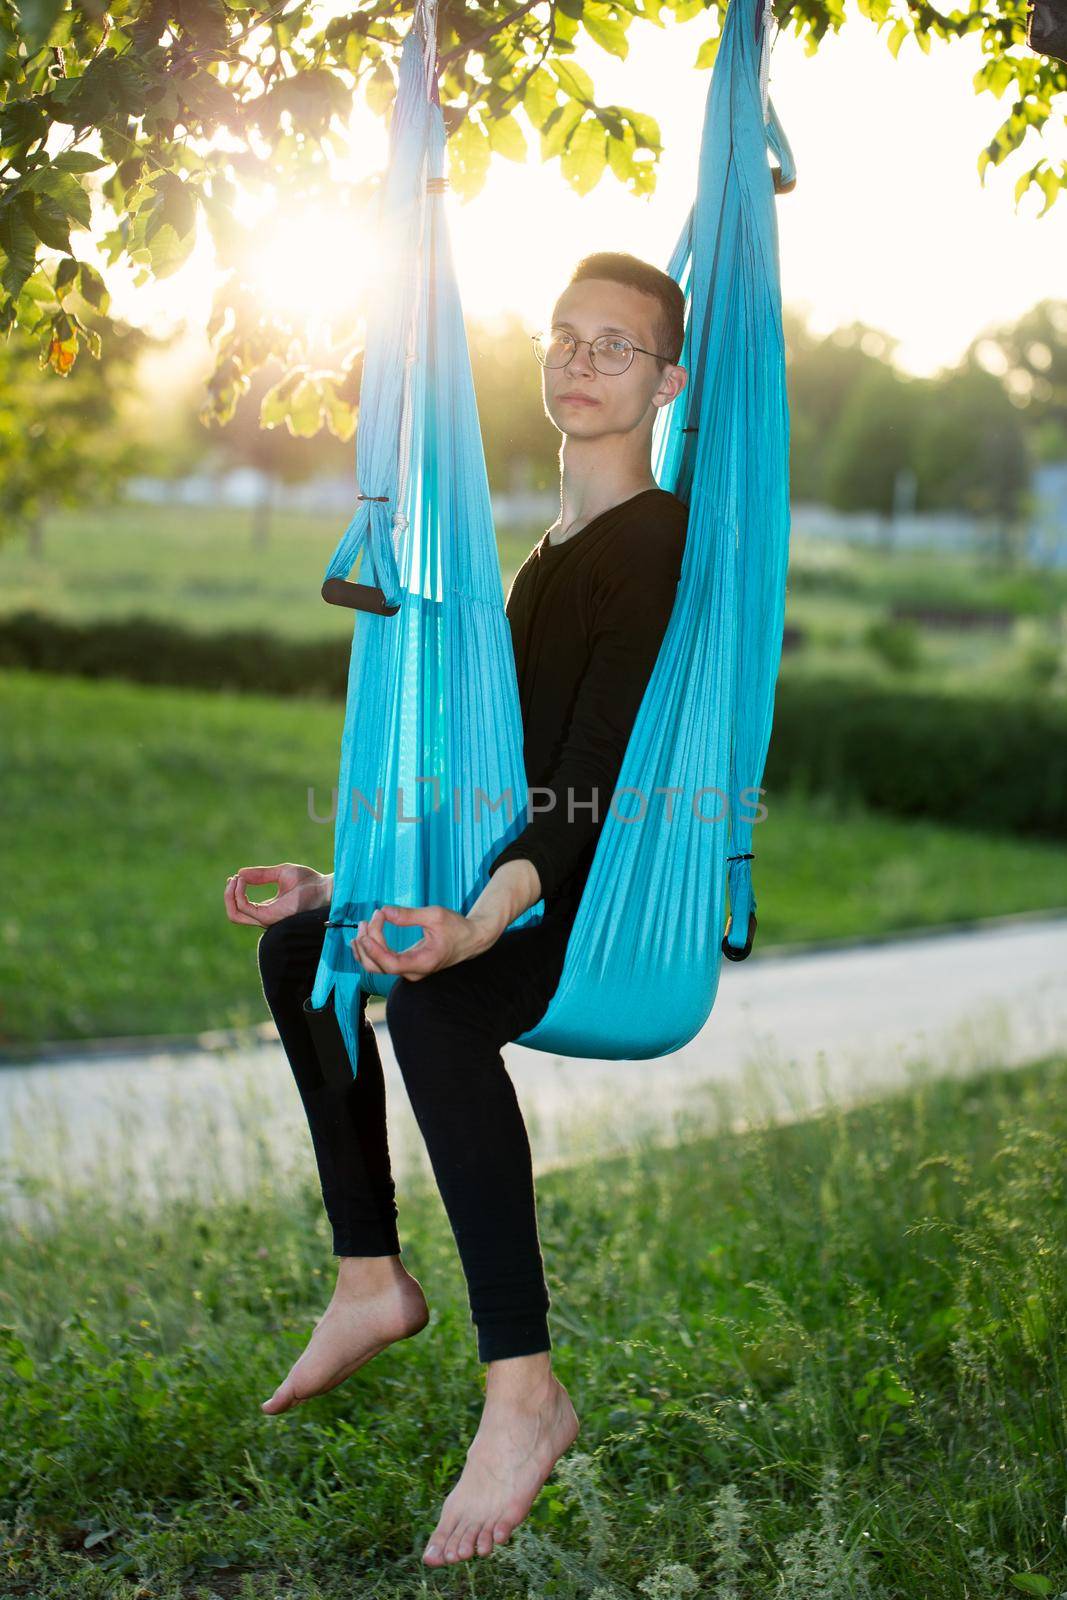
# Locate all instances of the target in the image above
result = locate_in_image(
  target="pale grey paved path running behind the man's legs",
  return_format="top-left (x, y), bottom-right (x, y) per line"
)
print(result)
top-left (0, 917), bottom-right (1067, 1213)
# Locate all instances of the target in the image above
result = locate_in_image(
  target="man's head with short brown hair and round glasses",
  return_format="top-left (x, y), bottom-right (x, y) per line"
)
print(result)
top-left (544, 250), bottom-right (688, 438)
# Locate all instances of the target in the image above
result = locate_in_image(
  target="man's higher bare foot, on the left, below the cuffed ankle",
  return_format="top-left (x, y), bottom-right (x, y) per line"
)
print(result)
top-left (261, 1256), bottom-right (430, 1416)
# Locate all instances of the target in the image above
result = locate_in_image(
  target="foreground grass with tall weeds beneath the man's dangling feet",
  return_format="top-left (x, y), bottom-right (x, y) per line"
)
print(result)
top-left (0, 1058), bottom-right (1067, 1600)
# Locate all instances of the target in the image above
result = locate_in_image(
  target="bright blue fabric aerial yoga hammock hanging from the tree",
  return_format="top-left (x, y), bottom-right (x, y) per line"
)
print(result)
top-left (306, 0), bottom-right (795, 1072)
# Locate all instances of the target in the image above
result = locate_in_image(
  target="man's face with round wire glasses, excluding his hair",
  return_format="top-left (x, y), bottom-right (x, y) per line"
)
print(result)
top-left (542, 278), bottom-right (688, 438)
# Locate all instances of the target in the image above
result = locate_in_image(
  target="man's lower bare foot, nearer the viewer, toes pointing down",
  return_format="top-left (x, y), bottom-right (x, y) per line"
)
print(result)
top-left (422, 1350), bottom-right (579, 1566)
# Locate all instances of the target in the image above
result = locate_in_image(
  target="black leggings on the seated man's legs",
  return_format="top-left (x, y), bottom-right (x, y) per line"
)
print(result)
top-left (258, 904), bottom-right (576, 1362)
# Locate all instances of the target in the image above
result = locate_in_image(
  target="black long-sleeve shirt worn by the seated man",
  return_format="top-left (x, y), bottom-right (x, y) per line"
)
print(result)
top-left (490, 488), bottom-right (688, 910)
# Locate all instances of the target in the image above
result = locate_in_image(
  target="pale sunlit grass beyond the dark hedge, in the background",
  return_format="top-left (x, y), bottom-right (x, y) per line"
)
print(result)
top-left (0, 502), bottom-right (1067, 694)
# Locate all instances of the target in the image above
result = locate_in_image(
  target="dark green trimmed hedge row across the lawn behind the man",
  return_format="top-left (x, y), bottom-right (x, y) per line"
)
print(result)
top-left (0, 613), bottom-right (1067, 838)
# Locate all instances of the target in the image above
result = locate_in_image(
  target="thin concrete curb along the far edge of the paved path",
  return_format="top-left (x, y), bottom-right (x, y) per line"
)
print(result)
top-left (8, 906), bottom-right (1067, 1069)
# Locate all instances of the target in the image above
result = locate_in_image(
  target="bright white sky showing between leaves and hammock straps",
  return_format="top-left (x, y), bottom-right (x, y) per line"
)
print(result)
top-left (109, 0), bottom-right (1067, 376)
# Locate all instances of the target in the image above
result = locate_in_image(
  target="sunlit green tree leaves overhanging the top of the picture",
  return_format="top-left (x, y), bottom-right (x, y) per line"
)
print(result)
top-left (0, 0), bottom-right (1067, 438)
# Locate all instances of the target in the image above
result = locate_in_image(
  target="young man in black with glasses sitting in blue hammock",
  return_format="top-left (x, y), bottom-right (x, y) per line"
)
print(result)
top-left (226, 253), bottom-right (688, 1566)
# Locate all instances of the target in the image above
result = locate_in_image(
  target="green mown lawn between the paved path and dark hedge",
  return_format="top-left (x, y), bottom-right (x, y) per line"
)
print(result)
top-left (0, 672), bottom-right (1067, 1046)
